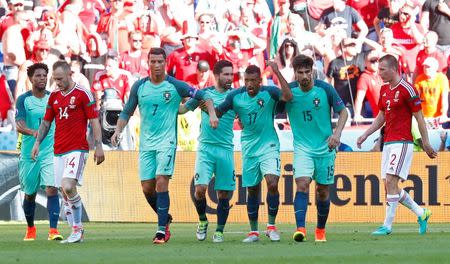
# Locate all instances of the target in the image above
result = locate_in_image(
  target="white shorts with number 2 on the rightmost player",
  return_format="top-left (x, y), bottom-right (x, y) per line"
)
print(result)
top-left (381, 142), bottom-right (413, 180)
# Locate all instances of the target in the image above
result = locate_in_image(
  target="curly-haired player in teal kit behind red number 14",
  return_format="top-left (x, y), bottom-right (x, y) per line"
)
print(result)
top-left (16, 63), bottom-right (62, 241)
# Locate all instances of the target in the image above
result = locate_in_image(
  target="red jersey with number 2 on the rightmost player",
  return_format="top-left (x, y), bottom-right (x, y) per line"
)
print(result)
top-left (378, 79), bottom-right (422, 142)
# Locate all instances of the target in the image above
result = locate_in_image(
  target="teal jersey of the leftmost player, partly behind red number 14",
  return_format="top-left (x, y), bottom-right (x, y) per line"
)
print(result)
top-left (16, 91), bottom-right (55, 160)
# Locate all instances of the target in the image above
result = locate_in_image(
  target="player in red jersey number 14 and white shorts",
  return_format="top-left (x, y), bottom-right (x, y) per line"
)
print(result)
top-left (31, 61), bottom-right (105, 243)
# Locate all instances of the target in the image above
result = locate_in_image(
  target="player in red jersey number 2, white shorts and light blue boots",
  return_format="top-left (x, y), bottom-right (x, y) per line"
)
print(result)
top-left (357, 55), bottom-right (437, 235)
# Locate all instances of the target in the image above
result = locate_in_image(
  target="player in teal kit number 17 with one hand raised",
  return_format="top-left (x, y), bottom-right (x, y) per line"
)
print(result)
top-left (216, 63), bottom-right (292, 242)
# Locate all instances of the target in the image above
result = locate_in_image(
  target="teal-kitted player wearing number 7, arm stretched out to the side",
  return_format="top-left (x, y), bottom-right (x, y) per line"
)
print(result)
top-left (111, 48), bottom-right (218, 244)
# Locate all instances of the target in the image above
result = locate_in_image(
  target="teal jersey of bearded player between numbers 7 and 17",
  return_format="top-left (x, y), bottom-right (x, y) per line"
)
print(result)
top-left (186, 86), bottom-right (236, 149)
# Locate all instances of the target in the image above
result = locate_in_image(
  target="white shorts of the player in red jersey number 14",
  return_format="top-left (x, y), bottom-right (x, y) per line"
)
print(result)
top-left (53, 151), bottom-right (88, 187)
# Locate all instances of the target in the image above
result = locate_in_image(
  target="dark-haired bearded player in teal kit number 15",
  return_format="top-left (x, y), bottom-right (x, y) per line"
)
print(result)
top-left (286, 55), bottom-right (348, 242)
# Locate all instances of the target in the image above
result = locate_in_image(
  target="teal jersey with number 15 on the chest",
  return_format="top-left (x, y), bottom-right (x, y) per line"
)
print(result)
top-left (286, 80), bottom-right (345, 156)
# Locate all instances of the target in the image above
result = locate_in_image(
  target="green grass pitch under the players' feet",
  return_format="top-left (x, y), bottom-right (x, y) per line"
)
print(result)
top-left (0, 223), bottom-right (450, 264)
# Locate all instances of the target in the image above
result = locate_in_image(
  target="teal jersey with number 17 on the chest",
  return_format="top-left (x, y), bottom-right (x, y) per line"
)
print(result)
top-left (217, 86), bottom-right (281, 157)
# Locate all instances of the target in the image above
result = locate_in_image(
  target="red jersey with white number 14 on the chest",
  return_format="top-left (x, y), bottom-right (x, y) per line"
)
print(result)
top-left (44, 84), bottom-right (98, 155)
